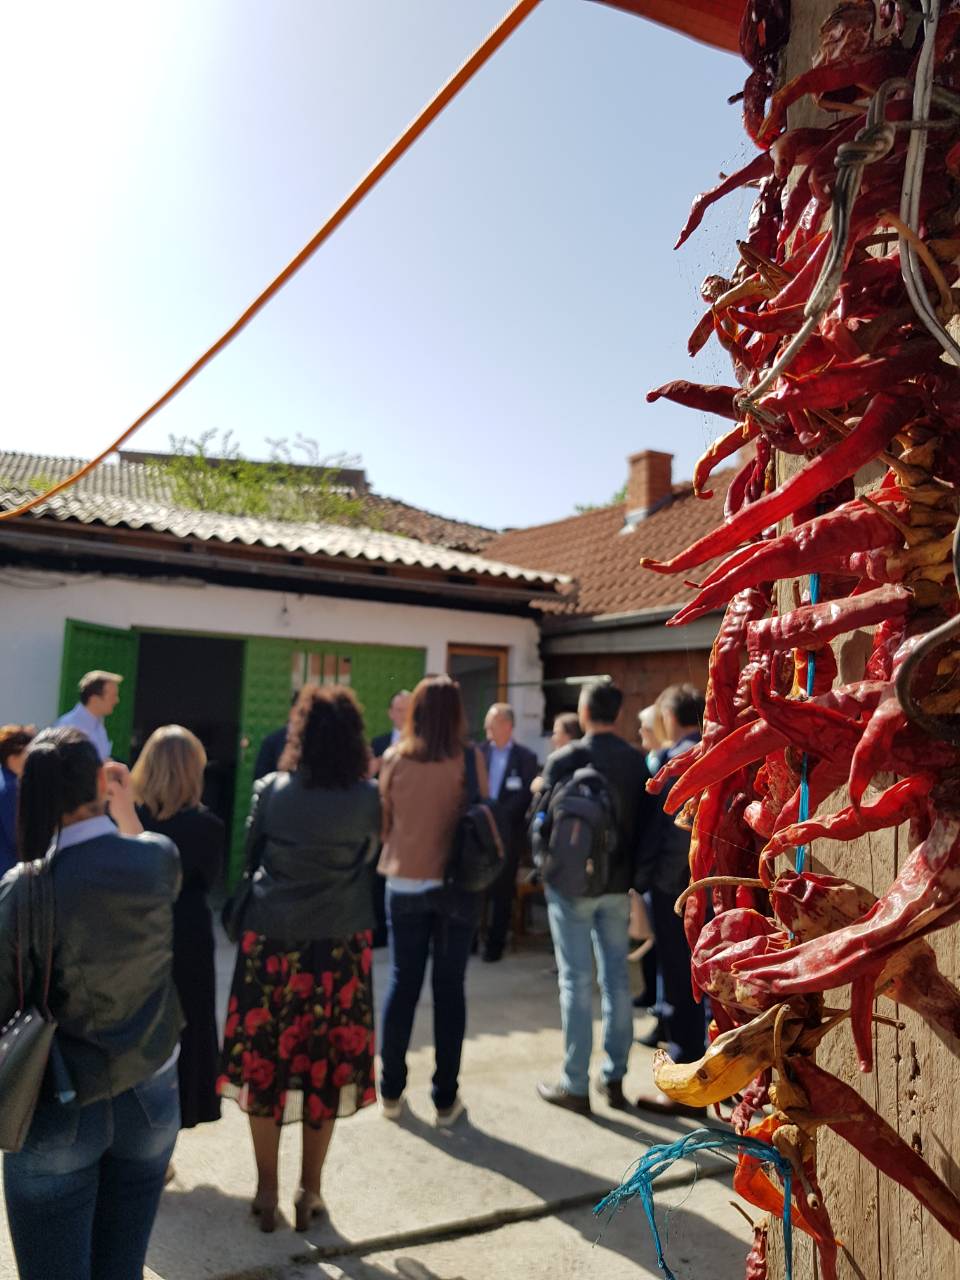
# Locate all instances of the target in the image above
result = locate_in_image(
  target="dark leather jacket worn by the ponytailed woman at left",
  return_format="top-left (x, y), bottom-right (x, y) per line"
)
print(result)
top-left (0, 833), bottom-right (183, 1105)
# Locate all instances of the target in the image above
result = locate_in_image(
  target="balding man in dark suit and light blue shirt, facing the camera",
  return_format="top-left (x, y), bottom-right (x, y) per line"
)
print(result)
top-left (483, 703), bottom-right (538, 963)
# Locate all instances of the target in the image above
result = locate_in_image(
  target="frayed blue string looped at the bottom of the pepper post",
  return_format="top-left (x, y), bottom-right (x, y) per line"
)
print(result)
top-left (594, 1129), bottom-right (794, 1280)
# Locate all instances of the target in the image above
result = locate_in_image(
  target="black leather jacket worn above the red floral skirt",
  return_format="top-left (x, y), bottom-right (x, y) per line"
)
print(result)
top-left (243, 773), bottom-right (380, 942)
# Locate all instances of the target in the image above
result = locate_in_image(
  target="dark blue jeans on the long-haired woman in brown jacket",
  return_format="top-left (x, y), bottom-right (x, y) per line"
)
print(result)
top-left (380, 888), bottom-right (477, 1111)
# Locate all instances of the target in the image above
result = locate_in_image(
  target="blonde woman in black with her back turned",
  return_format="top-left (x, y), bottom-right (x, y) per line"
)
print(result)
top-left (133, 724), bottom-right (225, 1129)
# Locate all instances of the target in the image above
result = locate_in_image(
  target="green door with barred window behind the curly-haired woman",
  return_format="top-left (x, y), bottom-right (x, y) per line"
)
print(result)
top-left (228, 636), bottom-right (426, 884)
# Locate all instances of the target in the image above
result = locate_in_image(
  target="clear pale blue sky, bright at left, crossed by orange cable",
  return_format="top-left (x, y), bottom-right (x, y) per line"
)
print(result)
top-left (0, 0), bottom-right (751, 526)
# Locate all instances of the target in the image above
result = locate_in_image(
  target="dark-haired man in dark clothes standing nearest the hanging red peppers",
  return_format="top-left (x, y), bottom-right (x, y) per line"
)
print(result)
top-left (635, 685), bottom-right (707, 1115)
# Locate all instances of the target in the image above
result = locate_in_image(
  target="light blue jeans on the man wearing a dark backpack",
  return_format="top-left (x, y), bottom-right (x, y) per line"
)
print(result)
top-left (547, 884), bottom-right (634, 1097)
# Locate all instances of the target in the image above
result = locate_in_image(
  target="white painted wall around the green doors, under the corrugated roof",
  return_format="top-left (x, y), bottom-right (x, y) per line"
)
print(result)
top-left (0, 568), bottom-right (543, 749)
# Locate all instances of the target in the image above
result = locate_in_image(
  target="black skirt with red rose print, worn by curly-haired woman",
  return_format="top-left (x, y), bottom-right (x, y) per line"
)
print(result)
top-left (216, 931), bottom-right (376, 1129)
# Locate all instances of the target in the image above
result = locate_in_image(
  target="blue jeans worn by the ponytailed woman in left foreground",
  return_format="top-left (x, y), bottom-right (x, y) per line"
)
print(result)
top-left (4, 1062), bottom-right (180, 1280)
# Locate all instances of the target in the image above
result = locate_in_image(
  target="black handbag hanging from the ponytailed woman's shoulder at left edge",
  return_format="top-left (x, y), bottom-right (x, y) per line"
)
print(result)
top-left (0, 859), bottom-right (56, 1152)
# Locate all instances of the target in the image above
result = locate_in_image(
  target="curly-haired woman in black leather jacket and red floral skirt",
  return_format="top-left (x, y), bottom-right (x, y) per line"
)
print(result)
top-left (219, 685), bottom-right (380, 1231)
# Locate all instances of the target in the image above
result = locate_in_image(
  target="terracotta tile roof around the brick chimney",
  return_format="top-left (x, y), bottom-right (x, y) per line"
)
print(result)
top-left (484, 470), bottom-right (736, 617)
